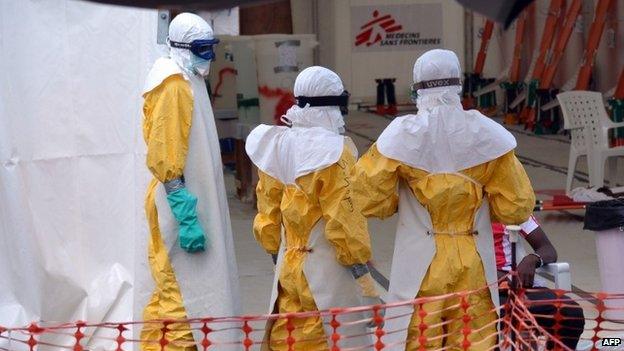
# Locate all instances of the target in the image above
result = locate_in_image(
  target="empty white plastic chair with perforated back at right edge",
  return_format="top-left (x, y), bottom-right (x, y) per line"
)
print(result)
top-left (557, 91), bottom-right (624, 191)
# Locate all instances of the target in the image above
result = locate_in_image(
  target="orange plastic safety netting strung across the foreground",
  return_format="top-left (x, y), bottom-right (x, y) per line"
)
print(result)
top-left (0, 276), bottom-right (624, 351)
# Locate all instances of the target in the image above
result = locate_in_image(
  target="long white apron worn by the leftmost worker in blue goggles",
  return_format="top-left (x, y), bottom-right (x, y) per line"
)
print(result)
top-left (140, 59), bottom-right (241, 349)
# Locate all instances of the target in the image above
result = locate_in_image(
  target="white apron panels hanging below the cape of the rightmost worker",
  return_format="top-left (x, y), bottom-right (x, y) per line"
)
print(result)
top-left (383, 180), bottom-right (499, 350)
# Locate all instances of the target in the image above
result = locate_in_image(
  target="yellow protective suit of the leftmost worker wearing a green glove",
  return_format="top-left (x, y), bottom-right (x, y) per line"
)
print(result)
top-left (141, 75), bottom-right (195, 350)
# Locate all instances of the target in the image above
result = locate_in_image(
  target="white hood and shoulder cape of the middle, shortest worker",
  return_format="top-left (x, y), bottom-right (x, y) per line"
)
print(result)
top-left (245, 66), bottom-right (357, 184)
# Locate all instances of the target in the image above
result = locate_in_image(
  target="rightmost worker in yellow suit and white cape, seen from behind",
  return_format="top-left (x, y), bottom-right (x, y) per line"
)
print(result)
top-left (354, 50), bottom-right (535, 350)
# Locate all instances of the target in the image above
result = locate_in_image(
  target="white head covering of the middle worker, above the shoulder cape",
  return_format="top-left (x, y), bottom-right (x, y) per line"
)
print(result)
top-left (282, 66), bottom-right (344, 134)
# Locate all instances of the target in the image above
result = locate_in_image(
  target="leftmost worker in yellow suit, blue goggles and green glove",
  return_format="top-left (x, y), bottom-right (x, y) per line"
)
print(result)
top-left (138, 13), bottom-right (240, 350)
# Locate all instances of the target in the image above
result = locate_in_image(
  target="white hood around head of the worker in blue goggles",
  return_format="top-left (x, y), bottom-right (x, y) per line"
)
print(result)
top-left (169, 12), bottom-right (214, 75)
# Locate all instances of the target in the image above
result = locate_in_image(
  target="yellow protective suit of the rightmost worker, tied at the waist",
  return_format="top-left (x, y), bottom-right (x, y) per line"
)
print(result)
top-left (355, 145), bottom-right (535, 350)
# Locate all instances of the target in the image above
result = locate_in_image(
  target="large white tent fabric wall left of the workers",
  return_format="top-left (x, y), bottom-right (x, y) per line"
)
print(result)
top-left (0, 0), bottom-right (157, 349)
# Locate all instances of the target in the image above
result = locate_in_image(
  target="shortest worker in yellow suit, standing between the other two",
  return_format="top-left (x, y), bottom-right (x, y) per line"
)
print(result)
top-left (246, 66), bottom-right (380, 350)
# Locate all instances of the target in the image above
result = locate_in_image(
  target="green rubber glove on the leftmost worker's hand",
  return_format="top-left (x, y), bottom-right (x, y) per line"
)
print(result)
top-left (167, 188), bottom-right (206, 253)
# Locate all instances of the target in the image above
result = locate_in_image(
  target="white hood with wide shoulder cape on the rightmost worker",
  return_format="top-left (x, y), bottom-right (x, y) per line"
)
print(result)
top-left (377, 49), bottom-right (516, 173)
